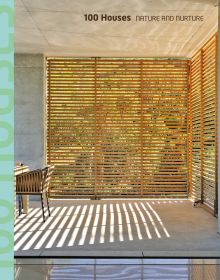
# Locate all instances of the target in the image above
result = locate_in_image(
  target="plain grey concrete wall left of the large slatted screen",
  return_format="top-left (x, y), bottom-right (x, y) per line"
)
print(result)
top-left (14, 54), bottom-right (44, 169)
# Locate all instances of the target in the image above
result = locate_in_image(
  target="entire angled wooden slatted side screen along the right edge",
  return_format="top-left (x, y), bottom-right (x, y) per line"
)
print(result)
top-left (190, 35), bottom-right (218, 212)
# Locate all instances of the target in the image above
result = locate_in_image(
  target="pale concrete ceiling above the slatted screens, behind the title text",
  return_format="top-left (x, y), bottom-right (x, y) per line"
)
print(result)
top-left (15, 0), bottom-right (218, 57)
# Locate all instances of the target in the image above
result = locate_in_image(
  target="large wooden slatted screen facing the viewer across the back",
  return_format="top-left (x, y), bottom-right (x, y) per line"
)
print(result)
top-left (47, 58), bottom-right (189, 197)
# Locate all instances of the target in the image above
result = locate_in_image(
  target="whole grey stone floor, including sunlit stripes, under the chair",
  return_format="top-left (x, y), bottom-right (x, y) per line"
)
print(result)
top-left (14, 199), bottom-right (220, 257)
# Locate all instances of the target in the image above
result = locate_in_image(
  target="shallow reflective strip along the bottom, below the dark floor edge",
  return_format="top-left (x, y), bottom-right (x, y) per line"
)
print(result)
top-left (15, 259), bottom-right (220, 280)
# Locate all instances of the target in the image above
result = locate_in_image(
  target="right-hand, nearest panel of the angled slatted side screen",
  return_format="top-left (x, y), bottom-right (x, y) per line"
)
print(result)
top-left (202, 36), bottom-right (217, 208)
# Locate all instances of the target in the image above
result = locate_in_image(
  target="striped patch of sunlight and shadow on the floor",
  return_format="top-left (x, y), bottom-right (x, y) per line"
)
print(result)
top-left (14, 200), bottom-right (170, 253)
